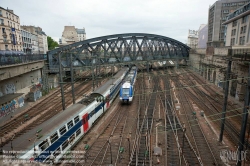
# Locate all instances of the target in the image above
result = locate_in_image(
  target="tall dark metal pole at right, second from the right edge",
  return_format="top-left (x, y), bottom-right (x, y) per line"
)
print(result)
top-left (219, 49), bottom-right (232, 142)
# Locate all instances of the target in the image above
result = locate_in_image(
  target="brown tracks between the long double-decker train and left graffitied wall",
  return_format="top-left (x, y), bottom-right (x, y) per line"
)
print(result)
top-left (0, 69), bottom-right (111, 146)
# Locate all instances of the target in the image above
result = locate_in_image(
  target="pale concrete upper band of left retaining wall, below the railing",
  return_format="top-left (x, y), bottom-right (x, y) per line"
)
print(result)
top-left (0, 61), bottom-right (44, 81)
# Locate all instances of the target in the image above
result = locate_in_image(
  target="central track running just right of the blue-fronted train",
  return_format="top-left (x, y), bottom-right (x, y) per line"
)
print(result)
top-left (129, 72), bottom-right (158, 166)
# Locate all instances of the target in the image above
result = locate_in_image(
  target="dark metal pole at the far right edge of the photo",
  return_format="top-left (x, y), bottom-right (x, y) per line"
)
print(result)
top-left (237, 63), bottom-right (250, 166)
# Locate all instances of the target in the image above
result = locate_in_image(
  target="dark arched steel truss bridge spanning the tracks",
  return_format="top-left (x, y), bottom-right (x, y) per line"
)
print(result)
top-left (48, 33), bottom-right (190, 72)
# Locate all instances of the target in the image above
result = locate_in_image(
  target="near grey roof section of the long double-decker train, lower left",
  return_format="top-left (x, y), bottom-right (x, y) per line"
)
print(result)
top-left (3, 104), bottom-right (86, 151)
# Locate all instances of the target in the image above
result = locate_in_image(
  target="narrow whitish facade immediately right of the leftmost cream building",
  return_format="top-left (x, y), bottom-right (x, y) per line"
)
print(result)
top-left (21, 29), bottom-right (32, 54)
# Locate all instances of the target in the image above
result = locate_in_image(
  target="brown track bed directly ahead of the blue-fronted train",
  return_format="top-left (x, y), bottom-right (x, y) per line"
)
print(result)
top-left (62, 69), bottom-right (141, 166)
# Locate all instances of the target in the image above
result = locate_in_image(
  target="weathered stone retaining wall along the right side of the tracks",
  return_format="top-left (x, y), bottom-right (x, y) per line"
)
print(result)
top-left (189, 47), bottom-right (248, 101)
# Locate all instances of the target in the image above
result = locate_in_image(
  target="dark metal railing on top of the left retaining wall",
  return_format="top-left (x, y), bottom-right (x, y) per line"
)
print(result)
top-left (0, 51), bottom-right (47, 66)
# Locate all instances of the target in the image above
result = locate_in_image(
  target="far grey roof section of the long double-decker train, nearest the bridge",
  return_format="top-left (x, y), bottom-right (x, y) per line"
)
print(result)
top-left (91, 68), bottom-right (128, 96)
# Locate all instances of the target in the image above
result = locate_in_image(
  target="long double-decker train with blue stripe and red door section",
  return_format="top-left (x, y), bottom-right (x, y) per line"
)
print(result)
top-left (3, 67), bottom-right (130, 163)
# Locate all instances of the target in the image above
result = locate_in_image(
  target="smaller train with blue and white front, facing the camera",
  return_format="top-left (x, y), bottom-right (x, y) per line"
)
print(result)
top-left (120, 66), bottom-right (137, 103)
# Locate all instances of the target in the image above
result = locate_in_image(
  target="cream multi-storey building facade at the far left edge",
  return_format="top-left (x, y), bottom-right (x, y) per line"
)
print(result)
top-left (0, 7), bottom-right (23, 52)
